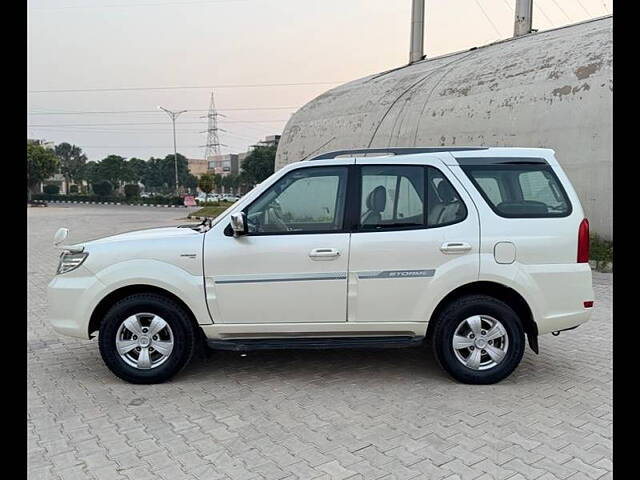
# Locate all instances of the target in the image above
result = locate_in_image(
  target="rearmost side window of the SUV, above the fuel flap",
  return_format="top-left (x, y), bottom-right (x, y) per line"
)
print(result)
top-left (462, 163), bottom-right (571, 218)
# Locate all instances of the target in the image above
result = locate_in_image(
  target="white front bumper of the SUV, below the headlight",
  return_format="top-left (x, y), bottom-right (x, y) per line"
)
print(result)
top-left (47, 266), bottom-right (105, 338)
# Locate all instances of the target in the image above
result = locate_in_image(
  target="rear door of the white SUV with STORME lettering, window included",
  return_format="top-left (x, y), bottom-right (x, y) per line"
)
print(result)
top-left (347, 155), bottom-right (480, 322)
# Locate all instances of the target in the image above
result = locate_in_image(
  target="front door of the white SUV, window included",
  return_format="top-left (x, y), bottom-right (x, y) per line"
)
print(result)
top-left (204, 160), bottom-right (353, 323)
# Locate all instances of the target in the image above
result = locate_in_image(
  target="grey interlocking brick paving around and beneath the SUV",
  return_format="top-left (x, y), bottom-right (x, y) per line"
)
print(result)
top-left (27, 206), bottom-right (612, 480)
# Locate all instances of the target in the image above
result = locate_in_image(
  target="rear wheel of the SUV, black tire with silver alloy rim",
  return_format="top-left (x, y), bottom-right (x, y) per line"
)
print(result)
top-left (431, 295), bottom-right (525, 385)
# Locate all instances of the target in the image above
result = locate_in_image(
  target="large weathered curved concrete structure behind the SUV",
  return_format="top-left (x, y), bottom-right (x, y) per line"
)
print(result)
top-left (276, 17), bottom-right (613, 238)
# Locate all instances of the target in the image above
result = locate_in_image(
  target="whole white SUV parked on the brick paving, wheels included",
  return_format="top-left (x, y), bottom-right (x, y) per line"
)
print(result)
top-left (48, 147), bottom-right (593, 384)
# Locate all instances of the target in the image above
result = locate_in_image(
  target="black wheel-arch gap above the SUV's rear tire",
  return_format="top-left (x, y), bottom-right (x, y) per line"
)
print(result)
top-left (426, 281), bottom-right (538, 353)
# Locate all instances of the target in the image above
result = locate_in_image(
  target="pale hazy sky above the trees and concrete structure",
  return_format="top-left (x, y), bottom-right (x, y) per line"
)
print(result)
top-left (27, 0), bottom-right (613, 160)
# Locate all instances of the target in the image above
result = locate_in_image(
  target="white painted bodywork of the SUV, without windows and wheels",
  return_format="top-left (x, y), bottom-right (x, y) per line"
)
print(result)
top-left (48, 148), bottom-right (593, 344)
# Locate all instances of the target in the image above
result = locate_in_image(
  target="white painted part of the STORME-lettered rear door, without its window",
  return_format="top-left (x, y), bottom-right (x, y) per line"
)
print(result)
top-left (348, 154), bottom-right (480, 322)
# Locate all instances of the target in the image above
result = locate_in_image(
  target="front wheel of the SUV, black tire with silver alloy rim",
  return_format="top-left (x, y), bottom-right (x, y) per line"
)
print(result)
top-left (98, 293), bottom-right (199, 384)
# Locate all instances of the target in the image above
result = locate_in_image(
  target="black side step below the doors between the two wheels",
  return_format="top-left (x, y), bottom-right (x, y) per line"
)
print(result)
top-left (207, 336), bottom-right (424, 352)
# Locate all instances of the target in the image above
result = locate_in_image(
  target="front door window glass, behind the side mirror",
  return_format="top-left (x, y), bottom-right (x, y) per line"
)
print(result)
top-left (246, 167), bottom-right (347, 234)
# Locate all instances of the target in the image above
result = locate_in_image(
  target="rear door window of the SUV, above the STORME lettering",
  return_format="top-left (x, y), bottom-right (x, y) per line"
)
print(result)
top-left (359, 165), bottom-right (467, 230)
